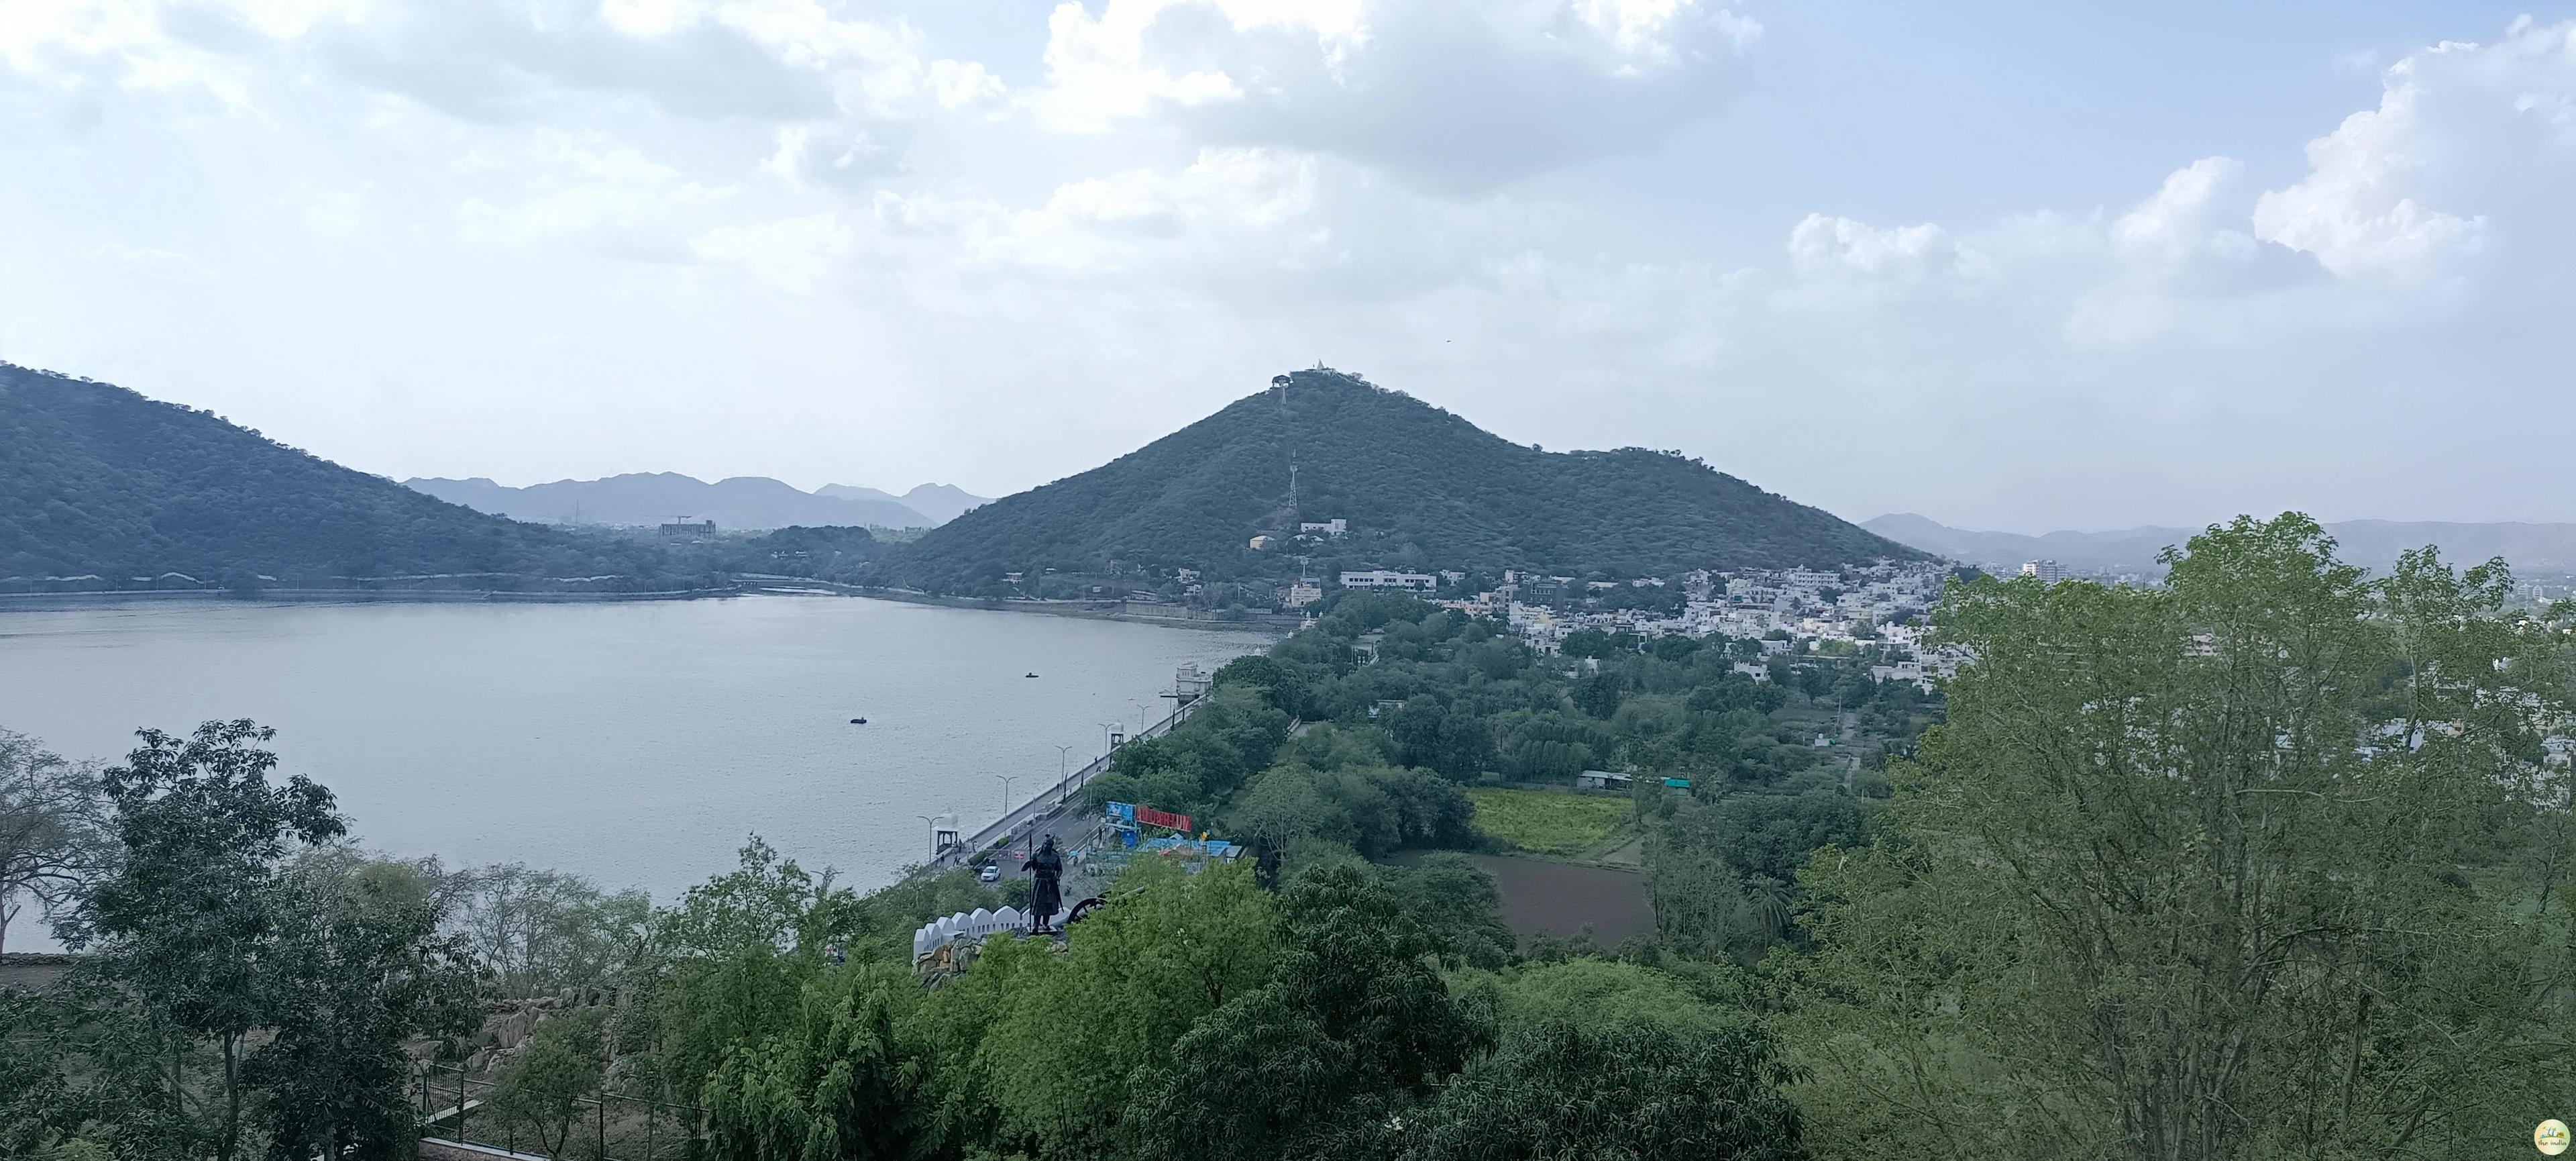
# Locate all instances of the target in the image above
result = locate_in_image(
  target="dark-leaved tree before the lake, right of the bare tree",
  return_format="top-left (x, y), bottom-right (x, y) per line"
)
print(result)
top-left (64, 721), bottom-right (345, 1161)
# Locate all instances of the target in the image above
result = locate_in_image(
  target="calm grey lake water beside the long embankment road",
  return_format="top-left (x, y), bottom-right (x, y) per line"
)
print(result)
top-left (0, 597), bottom-right (1270, 916)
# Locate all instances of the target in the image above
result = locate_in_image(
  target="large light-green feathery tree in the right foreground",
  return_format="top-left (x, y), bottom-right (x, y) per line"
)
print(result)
top-left (1795, 515), bottom-right (2576, 1161)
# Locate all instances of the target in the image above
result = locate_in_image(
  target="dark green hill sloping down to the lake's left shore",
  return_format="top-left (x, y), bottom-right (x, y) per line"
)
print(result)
top-left (0, 363), bottom-right (675, 589)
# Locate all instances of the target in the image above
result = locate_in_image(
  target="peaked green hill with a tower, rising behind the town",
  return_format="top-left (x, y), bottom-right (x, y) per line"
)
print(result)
top-left (894, 370), bottom-right (1924, 592)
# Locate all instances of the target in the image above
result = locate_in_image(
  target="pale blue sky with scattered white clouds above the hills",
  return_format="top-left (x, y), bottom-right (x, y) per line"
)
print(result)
top-left (0, 0), bottom-right (2576, 533)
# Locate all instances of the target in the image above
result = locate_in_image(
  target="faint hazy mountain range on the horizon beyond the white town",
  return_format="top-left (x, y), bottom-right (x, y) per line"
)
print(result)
top-left (1860, 512), bottom-right (2576, 574)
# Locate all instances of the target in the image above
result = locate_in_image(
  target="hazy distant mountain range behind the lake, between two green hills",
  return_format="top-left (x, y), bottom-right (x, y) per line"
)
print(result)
top-left (402, 471), bottom-right (984, 530)
